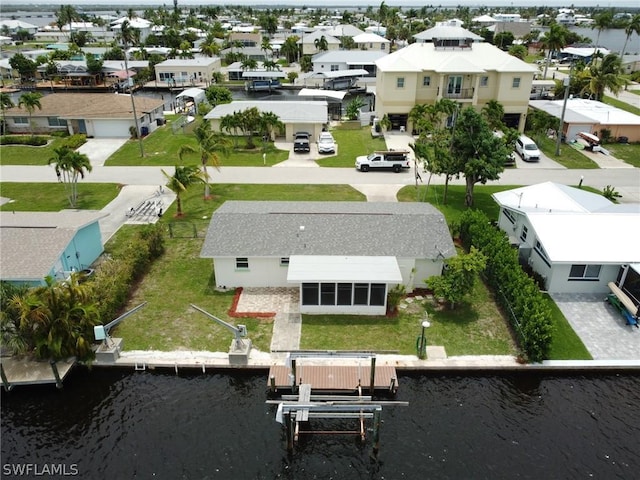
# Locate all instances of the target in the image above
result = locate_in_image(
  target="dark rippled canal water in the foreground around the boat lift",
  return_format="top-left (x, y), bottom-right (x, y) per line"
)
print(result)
top-left (0, 368), bottom-right (640, 480)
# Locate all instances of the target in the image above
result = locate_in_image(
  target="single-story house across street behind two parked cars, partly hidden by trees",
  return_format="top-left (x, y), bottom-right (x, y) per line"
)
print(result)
top-left (205, 100), bottom-right (329, 142)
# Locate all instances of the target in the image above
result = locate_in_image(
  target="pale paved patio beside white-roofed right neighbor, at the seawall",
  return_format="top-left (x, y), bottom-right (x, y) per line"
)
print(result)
top-left (551, 293), bottom-right (640, 360)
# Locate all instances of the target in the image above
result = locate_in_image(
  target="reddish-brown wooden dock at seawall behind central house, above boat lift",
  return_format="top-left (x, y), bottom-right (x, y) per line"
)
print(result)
top-left (269, 364), bottom-right (398, 394)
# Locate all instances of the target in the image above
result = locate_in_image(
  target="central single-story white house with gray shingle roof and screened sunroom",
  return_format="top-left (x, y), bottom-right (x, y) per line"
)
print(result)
top-left (200, 201), bottom-right (455, 315)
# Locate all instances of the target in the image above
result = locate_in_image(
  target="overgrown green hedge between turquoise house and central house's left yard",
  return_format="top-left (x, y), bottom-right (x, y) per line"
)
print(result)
top-left (93, 225), bottom-right (164, 323)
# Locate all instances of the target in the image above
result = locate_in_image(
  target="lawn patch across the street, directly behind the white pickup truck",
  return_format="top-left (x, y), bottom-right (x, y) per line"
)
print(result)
top-left (317, 127), bottom-right (387, 168)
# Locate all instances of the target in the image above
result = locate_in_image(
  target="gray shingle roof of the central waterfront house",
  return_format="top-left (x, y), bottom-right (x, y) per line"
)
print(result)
top-left (200, 201), bottom-right (455, 258)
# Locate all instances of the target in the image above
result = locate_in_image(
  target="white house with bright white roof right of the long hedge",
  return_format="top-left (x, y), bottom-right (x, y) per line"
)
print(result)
top-left (492, 182), bottom-right (640, 293)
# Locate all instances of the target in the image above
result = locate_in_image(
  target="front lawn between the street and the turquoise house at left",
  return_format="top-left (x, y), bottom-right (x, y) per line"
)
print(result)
top-left (0, 183), bottom-right (120, 212)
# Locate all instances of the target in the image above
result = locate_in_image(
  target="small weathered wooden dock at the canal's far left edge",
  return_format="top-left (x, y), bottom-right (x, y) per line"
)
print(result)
top-left (0, 357), bottom-right (76, 391)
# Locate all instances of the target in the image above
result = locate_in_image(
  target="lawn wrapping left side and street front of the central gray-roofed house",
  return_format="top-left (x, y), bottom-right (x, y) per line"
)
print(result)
top-left (106, 184), bottom-right (365, 352)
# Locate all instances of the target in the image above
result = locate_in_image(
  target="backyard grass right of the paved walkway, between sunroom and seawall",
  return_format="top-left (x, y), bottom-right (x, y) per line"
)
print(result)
top-left (300, 282), bottom-right (516, 356)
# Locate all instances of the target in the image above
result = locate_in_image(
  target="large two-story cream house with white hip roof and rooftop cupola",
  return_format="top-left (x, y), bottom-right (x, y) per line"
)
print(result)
top-left (376, 27), bottom-right (538, 131)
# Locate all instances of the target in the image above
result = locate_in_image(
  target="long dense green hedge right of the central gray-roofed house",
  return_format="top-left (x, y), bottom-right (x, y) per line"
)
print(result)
top-left (460, 210), bottom-right (553, 362)
